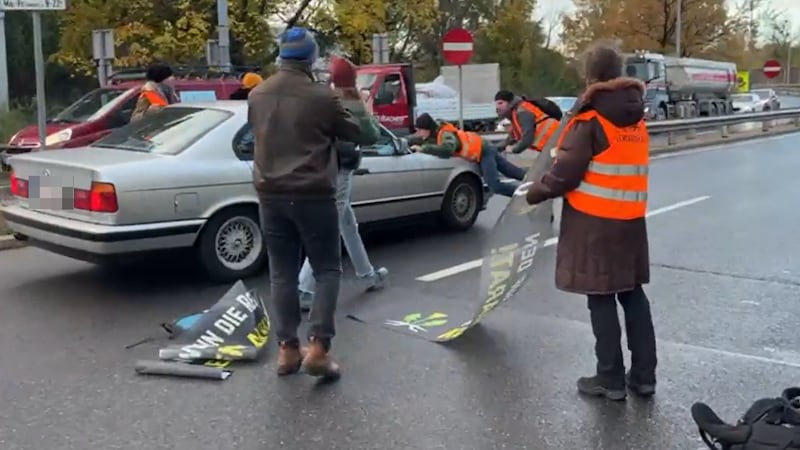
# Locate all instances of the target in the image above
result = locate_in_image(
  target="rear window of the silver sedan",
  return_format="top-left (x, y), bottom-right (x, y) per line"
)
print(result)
top-left (92, 106), bottom-right (233, 155)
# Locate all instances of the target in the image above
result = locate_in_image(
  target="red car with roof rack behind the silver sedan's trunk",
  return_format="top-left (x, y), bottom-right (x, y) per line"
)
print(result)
top-left (0, 69), bottom-right (247, 154)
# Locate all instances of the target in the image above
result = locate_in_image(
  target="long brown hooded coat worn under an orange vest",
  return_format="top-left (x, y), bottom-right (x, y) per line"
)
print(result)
top-left (527, 78), bottom-right (650, 294)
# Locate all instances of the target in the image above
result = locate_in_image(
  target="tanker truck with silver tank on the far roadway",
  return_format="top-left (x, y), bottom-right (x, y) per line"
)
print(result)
top-left (625, 51), bottom-right (737, 120)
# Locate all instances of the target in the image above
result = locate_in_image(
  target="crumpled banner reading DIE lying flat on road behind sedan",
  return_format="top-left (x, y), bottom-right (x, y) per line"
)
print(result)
top-left (136, 281), bottom-right (270, 379)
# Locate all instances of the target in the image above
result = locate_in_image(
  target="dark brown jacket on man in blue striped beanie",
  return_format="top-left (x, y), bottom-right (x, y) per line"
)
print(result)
top-left (247, 62), bottom-right (375, 199)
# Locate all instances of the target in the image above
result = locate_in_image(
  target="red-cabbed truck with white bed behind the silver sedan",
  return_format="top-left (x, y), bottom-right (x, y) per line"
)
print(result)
top-left (356, 63), bottom-right (500, 136)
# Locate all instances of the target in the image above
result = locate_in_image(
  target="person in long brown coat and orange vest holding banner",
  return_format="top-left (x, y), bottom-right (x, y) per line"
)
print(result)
top-left (526, 44), bottom-right (657, 400)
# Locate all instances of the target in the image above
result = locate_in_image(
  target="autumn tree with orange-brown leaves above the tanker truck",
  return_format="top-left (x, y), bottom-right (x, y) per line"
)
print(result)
top-left (562, 0), bottom-right (746, 56)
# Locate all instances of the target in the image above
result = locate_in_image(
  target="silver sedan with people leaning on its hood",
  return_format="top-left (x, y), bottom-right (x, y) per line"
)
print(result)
top-left (2, 101), bottom-right (488, 281)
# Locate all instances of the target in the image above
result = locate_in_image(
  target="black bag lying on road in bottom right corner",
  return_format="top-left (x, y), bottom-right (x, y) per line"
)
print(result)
top-left (692, 387), bottom-right (800, 450)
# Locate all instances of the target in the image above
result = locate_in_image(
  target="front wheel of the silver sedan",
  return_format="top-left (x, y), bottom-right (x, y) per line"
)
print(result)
top-left (440, 174), bottom-right (483, 231)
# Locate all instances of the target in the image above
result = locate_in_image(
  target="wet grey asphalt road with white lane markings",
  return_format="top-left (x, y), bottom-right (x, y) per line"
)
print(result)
top-left (0, 134), bottom-right (800, 450)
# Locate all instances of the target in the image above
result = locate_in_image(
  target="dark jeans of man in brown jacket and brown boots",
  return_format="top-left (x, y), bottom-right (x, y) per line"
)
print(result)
top-left (261, 198), bottom-right (342, 346)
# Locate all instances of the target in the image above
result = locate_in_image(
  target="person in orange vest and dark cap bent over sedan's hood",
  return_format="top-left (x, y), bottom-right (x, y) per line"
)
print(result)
top-left (408, 113), bottom-right (525, 197)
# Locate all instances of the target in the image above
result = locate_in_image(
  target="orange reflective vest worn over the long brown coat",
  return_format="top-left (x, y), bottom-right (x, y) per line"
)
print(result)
top-left (558, 111), bottom-right (650, 220)
